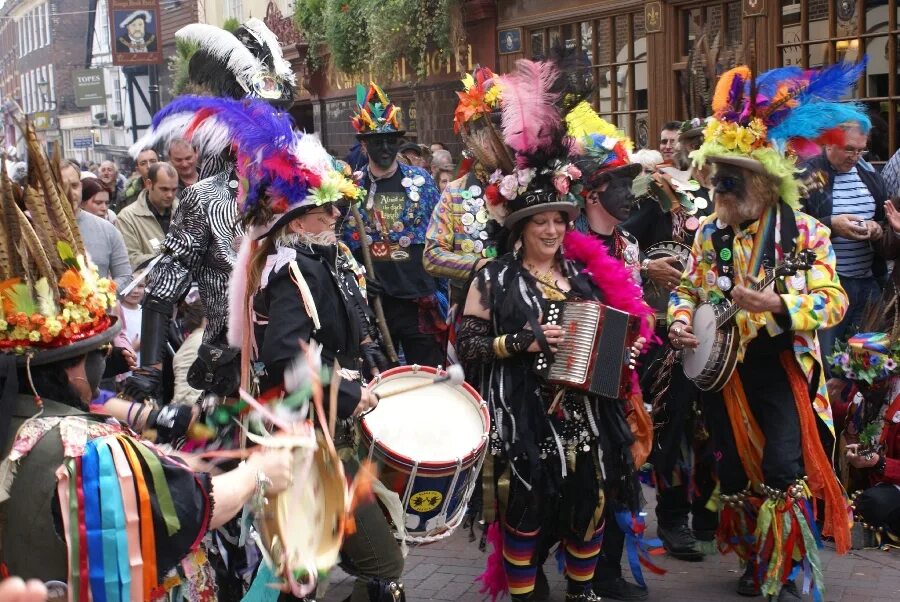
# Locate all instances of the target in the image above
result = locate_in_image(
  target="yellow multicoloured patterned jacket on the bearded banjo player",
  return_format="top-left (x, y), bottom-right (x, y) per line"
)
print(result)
top-left (668, 211), bottom-right (848, 434)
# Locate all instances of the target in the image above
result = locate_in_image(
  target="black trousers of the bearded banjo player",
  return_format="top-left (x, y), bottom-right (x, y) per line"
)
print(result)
top-left (703, 332), bottom-right (803, 494)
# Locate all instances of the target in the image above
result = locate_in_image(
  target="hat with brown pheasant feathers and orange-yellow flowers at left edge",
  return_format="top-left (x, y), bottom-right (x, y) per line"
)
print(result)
top-left (0, 122), bottom-right (121, 365)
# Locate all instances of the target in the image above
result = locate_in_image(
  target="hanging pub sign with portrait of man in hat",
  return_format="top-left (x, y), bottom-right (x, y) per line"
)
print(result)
top-left (109, 0), bottom-right (162, 67)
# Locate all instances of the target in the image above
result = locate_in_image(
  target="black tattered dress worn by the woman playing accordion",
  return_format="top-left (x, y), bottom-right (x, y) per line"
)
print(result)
top-left (459, 254), bottom-right (639, 533)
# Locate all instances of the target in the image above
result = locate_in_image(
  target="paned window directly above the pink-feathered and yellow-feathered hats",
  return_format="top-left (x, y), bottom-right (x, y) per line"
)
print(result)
top-left (526, 10), bottom-right (648, 148)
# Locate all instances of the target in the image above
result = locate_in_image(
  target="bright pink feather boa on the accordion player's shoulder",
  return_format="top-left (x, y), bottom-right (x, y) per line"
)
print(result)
top-left (563, 230), bottom-right (653, 350)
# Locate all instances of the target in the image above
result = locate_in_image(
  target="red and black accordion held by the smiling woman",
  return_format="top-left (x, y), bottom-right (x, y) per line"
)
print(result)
top-left (534, 301), bottom-right (639, 399)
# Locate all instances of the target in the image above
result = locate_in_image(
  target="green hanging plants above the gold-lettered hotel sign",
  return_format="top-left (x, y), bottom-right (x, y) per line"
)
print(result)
top-left (294, 0), bottom-right (463, 79)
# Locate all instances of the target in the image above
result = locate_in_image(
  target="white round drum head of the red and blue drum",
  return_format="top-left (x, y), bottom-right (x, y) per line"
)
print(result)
top-left (362, 368), bottom-right (488, 463)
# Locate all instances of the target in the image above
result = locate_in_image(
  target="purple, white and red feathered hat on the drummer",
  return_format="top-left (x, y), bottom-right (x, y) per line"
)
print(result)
top-left (131, 96), bottom-right (361, 238)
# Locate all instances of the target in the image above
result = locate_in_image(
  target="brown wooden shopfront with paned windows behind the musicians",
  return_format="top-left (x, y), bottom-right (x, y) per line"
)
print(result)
top-left (496, 0), bottom-right (900, 162)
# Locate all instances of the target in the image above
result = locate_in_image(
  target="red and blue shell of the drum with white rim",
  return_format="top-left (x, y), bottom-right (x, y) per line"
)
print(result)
top-left (358, 366), bottom-right (490, 537)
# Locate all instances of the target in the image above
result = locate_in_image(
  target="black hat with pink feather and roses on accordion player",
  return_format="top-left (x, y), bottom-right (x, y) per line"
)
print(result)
top-left (485, 60), bottom-right (581, 228)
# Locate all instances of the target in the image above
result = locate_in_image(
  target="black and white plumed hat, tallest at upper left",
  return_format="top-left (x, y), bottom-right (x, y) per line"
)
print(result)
top-left (175, 18), bottom-right (297, 108)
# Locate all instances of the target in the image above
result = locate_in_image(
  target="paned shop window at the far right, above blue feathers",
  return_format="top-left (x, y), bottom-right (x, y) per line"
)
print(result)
top-left (776, 0), bottom-right (900, 162)
